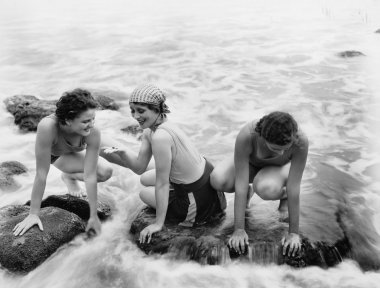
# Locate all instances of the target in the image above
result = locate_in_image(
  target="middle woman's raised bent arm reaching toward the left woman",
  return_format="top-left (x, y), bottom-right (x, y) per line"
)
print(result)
top-left (100, 131), bottom-right (152, 175)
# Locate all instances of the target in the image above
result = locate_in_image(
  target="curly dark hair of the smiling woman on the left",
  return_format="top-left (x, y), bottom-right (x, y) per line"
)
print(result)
top-left (55, 88), bottom-right (98, 125)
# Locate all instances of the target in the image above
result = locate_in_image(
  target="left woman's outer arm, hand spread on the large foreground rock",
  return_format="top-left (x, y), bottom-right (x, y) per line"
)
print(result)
top-left (13, 118), bottom-right (57, 236)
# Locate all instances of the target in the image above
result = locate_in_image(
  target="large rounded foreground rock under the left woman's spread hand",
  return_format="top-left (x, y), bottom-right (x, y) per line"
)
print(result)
top-left (0, 205), bottom-right (85, 273)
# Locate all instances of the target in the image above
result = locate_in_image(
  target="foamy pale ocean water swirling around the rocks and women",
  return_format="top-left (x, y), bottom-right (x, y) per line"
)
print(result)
top-left (0, 0), bottom-right (380, 288)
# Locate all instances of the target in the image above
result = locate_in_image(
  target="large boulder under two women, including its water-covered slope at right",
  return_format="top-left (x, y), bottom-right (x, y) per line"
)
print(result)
top-left (130, 164), bottom-right (380, 270)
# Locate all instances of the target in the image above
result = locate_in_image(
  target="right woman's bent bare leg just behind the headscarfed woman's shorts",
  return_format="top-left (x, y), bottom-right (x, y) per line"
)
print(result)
top-left (210, 157), bottom-right (235, 192)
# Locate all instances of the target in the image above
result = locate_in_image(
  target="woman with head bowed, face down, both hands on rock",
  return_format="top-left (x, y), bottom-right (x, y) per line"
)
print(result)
top-left (211, 112), bottom-right (309, 255)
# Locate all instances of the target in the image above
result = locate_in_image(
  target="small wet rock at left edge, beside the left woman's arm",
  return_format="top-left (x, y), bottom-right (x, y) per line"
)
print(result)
top-left (0, 161), bottom-right (28, 190)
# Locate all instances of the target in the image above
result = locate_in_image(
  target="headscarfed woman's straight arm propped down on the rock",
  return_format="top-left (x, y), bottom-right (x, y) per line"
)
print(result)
top-left (140, 130), bottom-right (172, 243)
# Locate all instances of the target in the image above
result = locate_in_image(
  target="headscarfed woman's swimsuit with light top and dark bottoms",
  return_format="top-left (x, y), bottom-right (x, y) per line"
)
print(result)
top-left (148, 122), bottom-right (226, 227)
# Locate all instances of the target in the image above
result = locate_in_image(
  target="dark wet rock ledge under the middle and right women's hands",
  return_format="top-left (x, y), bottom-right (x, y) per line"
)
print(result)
top-left (130, 208), bottom-right (350, 267)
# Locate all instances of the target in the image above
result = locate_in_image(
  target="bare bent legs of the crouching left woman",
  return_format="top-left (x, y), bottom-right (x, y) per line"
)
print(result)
top-left (53, 151), bottom-right (112, 196)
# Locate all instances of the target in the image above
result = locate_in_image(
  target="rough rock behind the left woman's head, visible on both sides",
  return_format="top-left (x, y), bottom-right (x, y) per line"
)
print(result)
top-left (4, 92), bottom-right (119, 131)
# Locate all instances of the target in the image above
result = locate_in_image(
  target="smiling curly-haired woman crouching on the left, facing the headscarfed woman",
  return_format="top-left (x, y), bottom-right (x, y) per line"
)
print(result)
top-left (13, 89), bottom-right (112, 236)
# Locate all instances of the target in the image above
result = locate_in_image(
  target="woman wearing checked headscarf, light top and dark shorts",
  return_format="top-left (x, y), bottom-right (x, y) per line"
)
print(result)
top-left (104, 85), bottom-right (225, 243)
